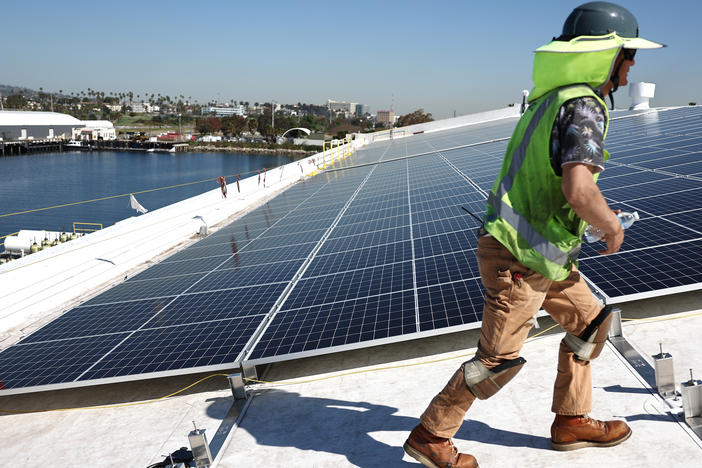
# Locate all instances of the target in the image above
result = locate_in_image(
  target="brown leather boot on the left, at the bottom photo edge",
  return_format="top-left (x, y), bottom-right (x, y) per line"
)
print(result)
top-left (404, 424), bottom-right (478, 468)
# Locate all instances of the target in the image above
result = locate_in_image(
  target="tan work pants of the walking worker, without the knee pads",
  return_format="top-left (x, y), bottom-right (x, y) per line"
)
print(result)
top-left (420, 236), bottom-right (600, 438)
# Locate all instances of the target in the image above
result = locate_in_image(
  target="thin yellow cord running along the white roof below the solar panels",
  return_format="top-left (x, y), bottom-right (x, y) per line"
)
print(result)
top-left (0, 312), bottom-right (702, 414)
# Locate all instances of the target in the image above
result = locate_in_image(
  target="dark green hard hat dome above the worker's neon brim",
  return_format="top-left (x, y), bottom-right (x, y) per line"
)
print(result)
top-left (561, 2), bottom-right (639, 40)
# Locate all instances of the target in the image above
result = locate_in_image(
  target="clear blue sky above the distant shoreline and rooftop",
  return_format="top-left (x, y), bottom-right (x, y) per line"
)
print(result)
top-left (0, 0), bottom-right (702, 118)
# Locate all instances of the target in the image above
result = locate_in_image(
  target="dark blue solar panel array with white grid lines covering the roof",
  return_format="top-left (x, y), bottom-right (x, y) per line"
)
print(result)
top-left (0, 107), bottom-right (702, 392)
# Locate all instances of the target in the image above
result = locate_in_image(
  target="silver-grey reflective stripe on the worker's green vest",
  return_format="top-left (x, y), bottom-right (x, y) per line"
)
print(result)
top-left (487, 93), bottom-right (581, 266)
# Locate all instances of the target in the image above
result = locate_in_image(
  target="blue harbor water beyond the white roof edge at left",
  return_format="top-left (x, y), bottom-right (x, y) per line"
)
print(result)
top-left (0, 151), bottom-right (292, 245)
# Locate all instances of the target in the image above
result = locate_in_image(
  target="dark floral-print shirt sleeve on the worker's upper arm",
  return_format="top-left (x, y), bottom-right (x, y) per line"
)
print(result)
top-left (551, 96), bottom-right (607, 177)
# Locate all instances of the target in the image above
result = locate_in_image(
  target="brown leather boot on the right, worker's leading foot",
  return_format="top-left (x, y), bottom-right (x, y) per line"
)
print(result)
top-left (551, 414), bottom-right (631, 451)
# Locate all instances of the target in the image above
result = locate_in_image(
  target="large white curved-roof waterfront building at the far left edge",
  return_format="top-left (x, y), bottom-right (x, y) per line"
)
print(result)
top-left (0, 111), bottom-right (85, 141)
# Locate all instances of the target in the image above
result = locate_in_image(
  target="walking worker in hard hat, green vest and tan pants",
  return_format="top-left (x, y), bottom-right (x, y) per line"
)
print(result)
top-left (404, 2), bottom-right (662, 468)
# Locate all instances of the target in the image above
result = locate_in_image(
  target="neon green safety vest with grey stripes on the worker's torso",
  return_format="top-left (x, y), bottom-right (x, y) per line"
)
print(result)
top-left (485, 85), bottom-right (609, 281)
